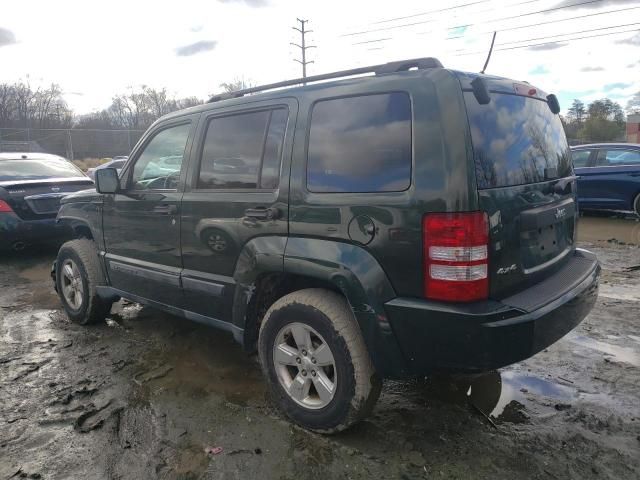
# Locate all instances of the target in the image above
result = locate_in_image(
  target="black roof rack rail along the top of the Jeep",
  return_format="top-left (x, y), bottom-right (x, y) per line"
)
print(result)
top-left (207, 57), bottom-right (442, 103)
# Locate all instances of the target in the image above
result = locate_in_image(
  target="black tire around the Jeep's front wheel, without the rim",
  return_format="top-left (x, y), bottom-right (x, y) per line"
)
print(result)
top-left (56, 239), bottom-right (113, 325)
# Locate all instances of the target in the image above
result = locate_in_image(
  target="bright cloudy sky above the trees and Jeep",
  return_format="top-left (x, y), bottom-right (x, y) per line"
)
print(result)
top-left (0, 0), bottom-right (640, 113)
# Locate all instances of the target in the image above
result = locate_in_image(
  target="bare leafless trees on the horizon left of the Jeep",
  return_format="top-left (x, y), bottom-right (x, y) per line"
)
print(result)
top-left (0, 79), bottom-right (252, 130)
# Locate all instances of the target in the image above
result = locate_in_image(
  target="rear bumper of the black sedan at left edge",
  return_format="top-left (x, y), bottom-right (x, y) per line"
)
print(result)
top-left (0, 213), bottom-right (72, 249)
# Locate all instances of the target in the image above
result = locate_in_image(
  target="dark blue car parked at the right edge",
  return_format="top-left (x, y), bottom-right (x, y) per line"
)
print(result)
top-left (571, 143), bottom-right (640, 216)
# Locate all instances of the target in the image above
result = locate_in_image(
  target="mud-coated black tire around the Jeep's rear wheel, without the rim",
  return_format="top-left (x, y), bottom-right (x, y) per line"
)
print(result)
top-left (258, 288), bottom-right (382, 433)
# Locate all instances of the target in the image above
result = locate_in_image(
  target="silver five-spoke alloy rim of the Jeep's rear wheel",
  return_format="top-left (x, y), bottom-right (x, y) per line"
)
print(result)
top-left (273, 322), bottom-right (338, 410)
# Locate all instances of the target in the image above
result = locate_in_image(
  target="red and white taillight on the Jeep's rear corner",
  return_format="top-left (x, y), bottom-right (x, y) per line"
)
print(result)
top-left (422, 212), bottom-right (489, 302)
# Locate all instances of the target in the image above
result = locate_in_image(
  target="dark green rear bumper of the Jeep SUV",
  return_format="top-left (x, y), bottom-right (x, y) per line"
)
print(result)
top-left (385, 249), bottom-right (600, 374)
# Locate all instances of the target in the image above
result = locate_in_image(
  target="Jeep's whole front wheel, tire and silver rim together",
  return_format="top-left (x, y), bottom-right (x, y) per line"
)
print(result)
top-left (56, 239), bottom-right (112, 325)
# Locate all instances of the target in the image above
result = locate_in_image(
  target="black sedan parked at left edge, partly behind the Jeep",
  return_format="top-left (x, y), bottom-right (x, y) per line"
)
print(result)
top-left (0, 152), bottom-right (93, 250)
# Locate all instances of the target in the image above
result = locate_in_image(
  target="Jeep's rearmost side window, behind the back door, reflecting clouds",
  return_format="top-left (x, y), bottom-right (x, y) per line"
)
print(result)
top-left (307, 92), bottom-right (412, 193)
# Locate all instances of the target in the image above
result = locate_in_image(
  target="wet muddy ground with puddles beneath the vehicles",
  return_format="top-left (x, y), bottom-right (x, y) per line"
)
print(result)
top-left (0, 217), bottom-right (640, 480)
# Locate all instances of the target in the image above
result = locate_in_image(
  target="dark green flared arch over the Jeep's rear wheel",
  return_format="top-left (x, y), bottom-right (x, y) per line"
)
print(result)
top-left (232, 237), bottom-right (406, 376)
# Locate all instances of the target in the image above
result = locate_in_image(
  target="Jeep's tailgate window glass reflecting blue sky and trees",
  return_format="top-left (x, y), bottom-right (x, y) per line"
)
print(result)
top-left (464, 92), bottom-right (572, 188)
